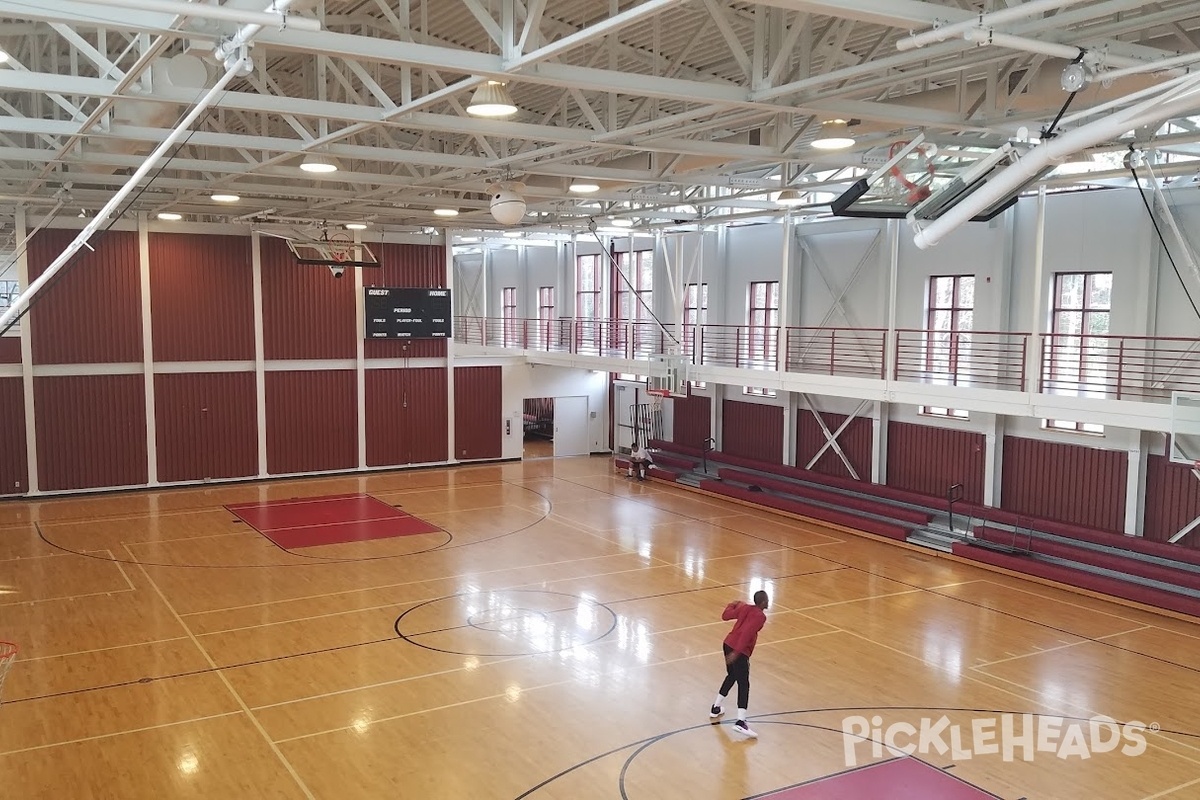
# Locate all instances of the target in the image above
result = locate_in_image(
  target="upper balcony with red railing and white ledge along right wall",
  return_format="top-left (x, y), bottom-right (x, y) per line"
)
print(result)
top-left (455, 317), bottom-right (1200, 431)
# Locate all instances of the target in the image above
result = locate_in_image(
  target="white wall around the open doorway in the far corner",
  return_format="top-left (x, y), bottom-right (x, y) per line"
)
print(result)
top-left (502, 363), bottom-right (608, 458)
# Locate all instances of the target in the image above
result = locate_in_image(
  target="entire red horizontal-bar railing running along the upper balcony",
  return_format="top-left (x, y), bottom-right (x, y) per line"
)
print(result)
top-left (455, 317), bottom-right (1200, 401)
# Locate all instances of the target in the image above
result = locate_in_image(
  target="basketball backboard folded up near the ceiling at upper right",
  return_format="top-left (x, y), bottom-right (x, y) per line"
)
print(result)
top-left (832, 137), bottom-right (1052, 223)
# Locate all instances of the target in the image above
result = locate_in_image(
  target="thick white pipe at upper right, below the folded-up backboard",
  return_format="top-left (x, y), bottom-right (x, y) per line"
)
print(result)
top-left (913, 76), bottom-right (1200, 249)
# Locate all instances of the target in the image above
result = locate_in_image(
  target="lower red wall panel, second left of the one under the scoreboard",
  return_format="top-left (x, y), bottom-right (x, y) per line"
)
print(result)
top-left (154, 372), bottom-right (258, 482)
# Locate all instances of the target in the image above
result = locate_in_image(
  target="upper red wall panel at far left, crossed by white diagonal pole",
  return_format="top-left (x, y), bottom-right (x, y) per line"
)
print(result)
top-left (26, 229), bottom-right (142, 363)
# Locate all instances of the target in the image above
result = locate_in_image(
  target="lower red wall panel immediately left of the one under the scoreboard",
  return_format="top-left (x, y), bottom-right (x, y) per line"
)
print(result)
top-left (266, 369), bottom-right (359, 475)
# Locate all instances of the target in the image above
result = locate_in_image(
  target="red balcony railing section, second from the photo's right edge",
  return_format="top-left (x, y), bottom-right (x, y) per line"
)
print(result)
top-left (892, 329), bottom-right (1030, 391)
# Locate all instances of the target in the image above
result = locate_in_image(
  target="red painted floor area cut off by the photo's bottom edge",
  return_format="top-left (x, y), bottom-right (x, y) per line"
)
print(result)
top-left (758, 758), bottom-right (996, 800)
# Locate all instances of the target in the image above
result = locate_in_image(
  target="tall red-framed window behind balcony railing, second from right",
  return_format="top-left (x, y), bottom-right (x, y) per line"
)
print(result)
top-left (919, 275), bottom-right (974, 420)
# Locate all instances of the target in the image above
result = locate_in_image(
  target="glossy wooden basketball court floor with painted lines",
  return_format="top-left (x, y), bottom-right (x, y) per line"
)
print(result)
top-left (0, 458), bottom-right (1200, 800)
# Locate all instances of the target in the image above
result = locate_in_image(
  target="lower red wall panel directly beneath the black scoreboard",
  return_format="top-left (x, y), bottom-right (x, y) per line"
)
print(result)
top-left (366, 367), bottom-right (448, 467)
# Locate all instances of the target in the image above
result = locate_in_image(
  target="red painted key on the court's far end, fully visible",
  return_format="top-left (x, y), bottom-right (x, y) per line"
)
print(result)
top-left (226, 494), bottom-right (442, 549)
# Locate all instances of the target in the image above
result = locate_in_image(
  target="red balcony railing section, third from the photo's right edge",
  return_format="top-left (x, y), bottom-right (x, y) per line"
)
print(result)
top-left (784, 327), bottom-right (888, 378)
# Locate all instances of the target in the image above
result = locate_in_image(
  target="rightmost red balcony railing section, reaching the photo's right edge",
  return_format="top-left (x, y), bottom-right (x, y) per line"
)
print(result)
top-left (1038, 333), bottom-right (1200, 401)
